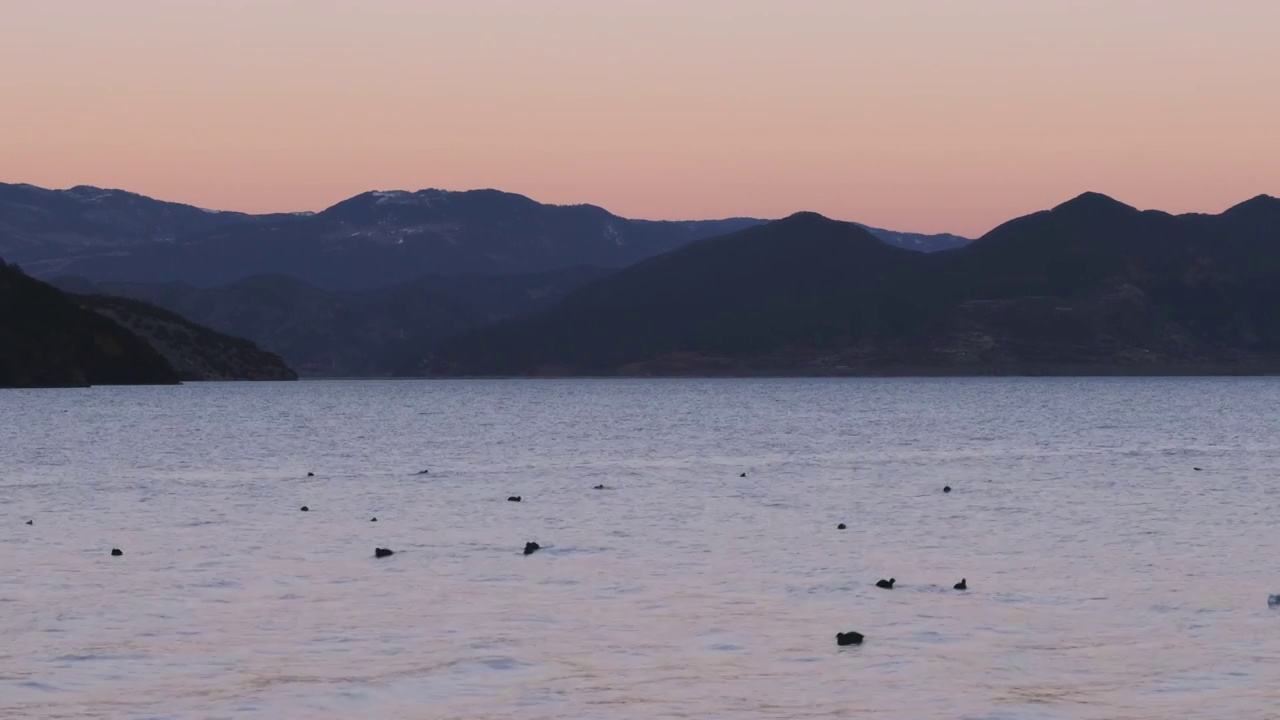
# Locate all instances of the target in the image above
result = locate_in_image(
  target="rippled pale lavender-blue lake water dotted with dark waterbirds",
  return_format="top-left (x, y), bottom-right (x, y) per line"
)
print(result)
top-left (0, 379), bottom-right (1280, 720)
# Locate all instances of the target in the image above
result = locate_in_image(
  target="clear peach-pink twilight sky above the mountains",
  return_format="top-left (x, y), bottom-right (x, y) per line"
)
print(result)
top-left (0, 0), bottom-right (1280, 236)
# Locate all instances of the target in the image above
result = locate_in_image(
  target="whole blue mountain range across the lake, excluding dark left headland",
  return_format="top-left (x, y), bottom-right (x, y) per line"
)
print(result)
top-left (10, 186), bottom-right (1280, 377)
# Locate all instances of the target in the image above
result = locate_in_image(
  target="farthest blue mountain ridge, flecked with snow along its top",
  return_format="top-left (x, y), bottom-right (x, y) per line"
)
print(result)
top-left (0, 184), bottom-right (966, 291)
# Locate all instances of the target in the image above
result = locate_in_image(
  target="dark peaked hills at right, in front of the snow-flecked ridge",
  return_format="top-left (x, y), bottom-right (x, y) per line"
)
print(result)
top-left (417, 193), bottom-right (1280, 375)
